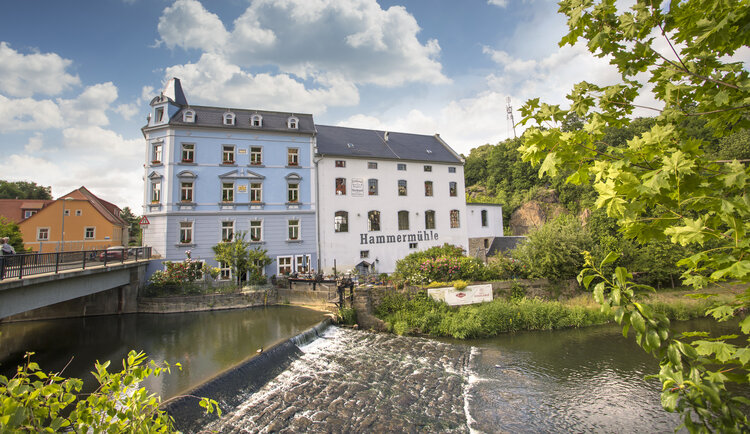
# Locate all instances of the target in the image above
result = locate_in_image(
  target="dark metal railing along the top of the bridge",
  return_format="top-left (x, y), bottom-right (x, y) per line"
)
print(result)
top-left (0, 247), bottom-right (151, 281)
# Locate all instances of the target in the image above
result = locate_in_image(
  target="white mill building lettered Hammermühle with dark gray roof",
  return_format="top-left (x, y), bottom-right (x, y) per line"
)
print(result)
top-left (316, 125), bottom-right (468, 273)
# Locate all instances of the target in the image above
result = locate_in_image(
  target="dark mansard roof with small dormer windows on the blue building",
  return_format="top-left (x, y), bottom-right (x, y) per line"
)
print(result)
top-left (169, 106), bottom-right (315, 134)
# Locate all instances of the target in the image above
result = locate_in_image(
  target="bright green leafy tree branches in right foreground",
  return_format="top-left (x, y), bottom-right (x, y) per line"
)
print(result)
top-left (521, 0), bottom-right (750, 432)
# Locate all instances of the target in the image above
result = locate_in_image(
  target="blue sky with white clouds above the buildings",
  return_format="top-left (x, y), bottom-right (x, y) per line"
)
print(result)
top-left (0, 0), bottom-right (700, 215)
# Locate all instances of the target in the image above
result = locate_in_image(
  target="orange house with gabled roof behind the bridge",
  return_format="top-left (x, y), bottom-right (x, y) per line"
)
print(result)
top-left (18, 187), bottom-right (129, 253)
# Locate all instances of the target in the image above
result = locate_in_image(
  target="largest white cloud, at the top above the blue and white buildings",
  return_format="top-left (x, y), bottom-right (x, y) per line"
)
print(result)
top-left (159, 0), bottom-right (450, 90)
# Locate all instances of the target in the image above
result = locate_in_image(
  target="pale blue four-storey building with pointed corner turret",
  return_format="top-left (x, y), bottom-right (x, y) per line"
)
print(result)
top-left (142, 79), bottom-right (318, 277)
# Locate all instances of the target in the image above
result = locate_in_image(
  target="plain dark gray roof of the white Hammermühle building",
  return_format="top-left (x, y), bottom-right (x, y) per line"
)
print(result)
top-left (316, 125), bottom-right (463, 164)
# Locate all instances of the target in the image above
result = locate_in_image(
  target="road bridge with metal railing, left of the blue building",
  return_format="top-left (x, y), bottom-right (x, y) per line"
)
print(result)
top-left (0, 247), bottom-right (151, 319)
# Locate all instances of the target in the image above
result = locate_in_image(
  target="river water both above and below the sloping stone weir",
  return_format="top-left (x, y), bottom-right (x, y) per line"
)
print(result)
top-left (0, 306), bottom-right (731, 433)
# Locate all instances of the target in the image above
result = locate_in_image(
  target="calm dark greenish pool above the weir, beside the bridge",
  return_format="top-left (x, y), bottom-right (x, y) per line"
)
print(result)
top-left (0, 306), bottom-right (324, 399)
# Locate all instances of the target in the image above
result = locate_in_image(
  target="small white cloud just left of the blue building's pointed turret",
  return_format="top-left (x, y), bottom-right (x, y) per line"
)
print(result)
top-left (57, 82), bottom-right (117, 125)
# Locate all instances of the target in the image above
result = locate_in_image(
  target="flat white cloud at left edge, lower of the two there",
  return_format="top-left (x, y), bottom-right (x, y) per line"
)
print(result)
top-left (0, 95), bottom-right (64, 133)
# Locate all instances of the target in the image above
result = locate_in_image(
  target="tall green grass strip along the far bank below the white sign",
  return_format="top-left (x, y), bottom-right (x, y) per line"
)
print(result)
top-left (373, 287), bottom-right (737, 339)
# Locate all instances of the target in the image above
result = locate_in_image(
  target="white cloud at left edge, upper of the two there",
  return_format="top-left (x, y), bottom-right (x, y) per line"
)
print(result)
top-left (0, 42), bottom-right (80, 97)
